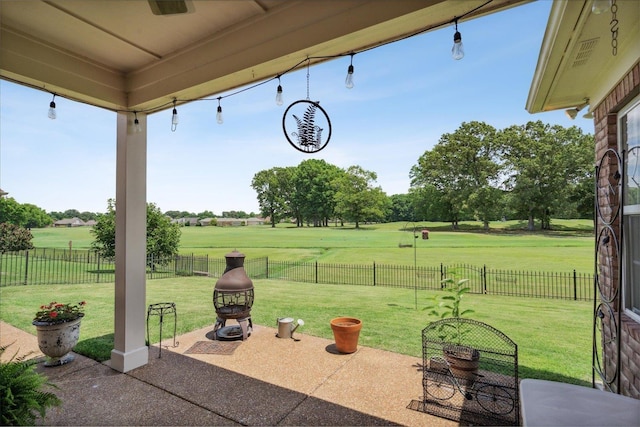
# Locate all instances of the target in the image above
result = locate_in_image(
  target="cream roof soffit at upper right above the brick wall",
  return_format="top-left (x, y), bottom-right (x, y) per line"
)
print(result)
top-left (526, 0), bottom-right (640, 113)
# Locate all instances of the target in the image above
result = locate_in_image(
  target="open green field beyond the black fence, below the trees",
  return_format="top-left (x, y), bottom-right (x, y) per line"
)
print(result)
top-left (32, 220), bottom-right (594, 273)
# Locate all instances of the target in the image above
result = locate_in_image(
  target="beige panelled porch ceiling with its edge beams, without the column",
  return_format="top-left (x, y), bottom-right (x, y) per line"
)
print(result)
top-left (0, 0), bottom-right (528, 112)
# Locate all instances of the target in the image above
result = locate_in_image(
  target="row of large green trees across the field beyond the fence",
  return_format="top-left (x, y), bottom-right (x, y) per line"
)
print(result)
top-left (251, 121), bottom-right (595, 230)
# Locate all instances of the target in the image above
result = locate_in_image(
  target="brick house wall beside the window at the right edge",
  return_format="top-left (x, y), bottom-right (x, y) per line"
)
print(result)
top-left (594, 62), bottom-right (640, 399)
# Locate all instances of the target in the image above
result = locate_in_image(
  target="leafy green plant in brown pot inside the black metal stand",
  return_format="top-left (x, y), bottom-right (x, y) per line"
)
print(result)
top-left (425, 276), bottom-right (480, 379)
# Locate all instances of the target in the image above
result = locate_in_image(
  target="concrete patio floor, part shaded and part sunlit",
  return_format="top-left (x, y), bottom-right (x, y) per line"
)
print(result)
top-left (0, 323), bottom-right (459, 427)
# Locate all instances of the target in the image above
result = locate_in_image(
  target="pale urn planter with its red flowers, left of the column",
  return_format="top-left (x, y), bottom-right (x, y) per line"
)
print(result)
top-left (32, 301), bottom-right (86, 366)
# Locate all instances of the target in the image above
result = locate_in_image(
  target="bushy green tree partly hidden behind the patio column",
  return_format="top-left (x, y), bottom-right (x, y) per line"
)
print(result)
top-left (91, 199), bottom-right (181, 264)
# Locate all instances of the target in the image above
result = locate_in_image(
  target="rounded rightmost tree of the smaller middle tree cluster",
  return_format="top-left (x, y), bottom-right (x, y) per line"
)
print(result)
top-left (334, 166), bottom-right (390, 228)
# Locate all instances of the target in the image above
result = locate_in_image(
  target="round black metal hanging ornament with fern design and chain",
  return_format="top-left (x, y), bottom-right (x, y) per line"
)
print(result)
top-left (282, 62), bottom-right (331, 153)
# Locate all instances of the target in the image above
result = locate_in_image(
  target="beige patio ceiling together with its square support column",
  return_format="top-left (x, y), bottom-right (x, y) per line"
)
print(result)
top-left (0, 0), bottom-right (525, 372)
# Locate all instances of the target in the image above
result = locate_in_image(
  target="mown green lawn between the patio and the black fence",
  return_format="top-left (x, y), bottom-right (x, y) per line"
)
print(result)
top-left (0, 278), bottom-right (593, 384)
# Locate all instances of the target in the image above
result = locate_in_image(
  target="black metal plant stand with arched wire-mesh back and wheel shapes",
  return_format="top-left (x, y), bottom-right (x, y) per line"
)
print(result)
top-left (412, 318), bottom-right (520, 425)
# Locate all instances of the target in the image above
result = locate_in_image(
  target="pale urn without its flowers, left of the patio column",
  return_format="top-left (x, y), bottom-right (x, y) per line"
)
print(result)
top-left (33, 316), bottom-right (82, 366)
